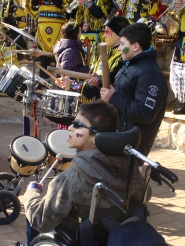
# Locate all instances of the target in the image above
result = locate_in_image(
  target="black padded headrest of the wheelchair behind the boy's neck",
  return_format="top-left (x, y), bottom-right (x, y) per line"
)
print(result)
top-left (95, 126), bottom-right (141, 155)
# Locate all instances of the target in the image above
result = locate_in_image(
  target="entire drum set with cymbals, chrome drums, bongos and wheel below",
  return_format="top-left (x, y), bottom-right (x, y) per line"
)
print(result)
top-left (0, 22), bottom-right (80, 225)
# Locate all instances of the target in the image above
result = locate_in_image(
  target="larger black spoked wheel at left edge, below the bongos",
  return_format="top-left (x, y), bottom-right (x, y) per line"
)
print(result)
top-left (0, 190), bottom-right (21, 225)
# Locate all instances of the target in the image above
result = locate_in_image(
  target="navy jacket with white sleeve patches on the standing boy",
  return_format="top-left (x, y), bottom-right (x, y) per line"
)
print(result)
top-left (109, 50), bottom-right (168, 165)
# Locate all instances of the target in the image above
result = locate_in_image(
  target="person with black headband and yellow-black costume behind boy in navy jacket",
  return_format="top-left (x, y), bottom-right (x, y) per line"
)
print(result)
top-left (55, 16), bottom-right (129, 99)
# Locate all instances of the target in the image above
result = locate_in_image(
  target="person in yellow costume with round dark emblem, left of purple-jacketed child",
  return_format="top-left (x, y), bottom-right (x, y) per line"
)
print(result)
top-left (33, 0), bottom-right (70, 79)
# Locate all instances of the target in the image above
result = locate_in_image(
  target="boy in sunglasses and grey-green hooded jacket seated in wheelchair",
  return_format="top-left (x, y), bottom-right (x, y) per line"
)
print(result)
top-left (17, 100), bottom-right (151, 246)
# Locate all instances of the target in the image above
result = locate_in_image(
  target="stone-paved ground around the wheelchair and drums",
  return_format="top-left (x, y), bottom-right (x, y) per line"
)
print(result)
top-left (0, 121), bottom-right (185, 246)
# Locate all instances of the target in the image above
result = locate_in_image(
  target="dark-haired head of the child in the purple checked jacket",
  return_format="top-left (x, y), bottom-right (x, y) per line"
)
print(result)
top-left (61, 21), bottom-right (80, 40)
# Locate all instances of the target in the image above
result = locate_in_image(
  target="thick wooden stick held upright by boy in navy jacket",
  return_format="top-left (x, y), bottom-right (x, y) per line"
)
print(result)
top-left (99, 42), bottom-right (110, 89)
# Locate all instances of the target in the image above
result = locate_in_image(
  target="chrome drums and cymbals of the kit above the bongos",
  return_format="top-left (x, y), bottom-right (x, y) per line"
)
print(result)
top-left (0, 22), bottom-right (80, 119)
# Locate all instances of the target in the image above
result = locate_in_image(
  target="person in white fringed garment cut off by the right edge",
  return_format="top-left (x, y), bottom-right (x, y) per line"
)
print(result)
top-left (170, 0), bottom-right (185, 115)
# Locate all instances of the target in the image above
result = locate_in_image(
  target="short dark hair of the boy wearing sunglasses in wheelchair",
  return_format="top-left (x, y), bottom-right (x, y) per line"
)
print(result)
top-left (78, 99), bottom-right (117, 135)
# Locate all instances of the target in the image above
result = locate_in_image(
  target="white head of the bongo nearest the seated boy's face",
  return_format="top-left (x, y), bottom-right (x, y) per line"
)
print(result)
top-left (46, 130), bottom-right (76, 158)
